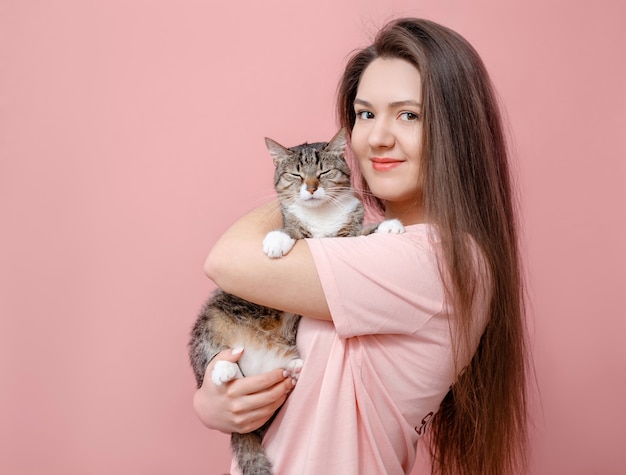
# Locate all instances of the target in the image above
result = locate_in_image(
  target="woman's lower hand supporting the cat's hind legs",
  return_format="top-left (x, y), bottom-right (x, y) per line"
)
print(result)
top-left (193, 349), bottom-right (295, 434)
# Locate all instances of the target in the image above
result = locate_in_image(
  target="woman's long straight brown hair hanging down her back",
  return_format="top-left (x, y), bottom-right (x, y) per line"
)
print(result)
top-left (337, 18), bottom-right (528, 475)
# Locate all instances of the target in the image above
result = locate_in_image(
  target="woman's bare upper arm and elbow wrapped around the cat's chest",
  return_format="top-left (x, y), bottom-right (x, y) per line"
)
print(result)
top-left (204, 201), bottom-right (331, 320)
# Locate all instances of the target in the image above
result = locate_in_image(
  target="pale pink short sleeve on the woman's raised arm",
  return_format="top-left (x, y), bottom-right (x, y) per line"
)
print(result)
top-left (307, 225), bottom-right (444, 338)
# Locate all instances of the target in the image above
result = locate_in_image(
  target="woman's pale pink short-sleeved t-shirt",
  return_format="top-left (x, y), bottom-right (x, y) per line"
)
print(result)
top-left (231, 224), bottom-right (486, 475)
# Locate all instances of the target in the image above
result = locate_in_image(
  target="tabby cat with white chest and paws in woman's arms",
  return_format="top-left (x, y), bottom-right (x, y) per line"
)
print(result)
top-left (189, 129), bottom-right (402, 475)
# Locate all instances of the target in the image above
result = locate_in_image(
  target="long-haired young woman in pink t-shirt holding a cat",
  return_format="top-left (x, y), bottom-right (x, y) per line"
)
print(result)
top-left (194, 19), bottom-right (527, 475)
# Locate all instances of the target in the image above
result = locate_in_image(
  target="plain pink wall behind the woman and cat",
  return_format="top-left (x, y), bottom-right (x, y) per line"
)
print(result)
top-left (0, 0), bottom-right (626, 475)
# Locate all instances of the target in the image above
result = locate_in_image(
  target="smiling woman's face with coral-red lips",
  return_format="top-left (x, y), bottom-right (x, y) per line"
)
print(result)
top-left (351, 58), bottom-right (422, 224)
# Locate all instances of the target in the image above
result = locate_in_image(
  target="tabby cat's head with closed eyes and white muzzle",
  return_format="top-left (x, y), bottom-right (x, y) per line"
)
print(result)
top-left (265, 129), bottom-right (351, 207)
